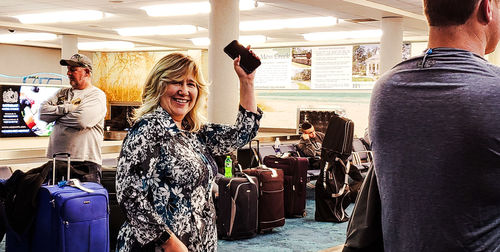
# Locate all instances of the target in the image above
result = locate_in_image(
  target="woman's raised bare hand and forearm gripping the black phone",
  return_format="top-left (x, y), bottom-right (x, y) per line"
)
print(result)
top-left (233, 46), bottom-right (260, 113)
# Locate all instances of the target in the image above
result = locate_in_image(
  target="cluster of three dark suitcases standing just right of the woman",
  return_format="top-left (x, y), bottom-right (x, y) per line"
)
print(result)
top-left (214, 140), bottom-right (309, 240)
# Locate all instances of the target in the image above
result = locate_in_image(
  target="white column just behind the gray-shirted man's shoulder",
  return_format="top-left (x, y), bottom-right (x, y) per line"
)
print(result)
top-left (380, 17), bottom-right (403, 74)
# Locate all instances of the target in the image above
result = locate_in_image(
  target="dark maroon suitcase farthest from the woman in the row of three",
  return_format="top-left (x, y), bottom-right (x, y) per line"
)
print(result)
top-left (264, 156), bottom-right (309, 217)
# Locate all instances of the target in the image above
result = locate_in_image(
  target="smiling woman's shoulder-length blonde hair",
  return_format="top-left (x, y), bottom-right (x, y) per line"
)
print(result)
top-left (132, 53), bottom-right (208, 131)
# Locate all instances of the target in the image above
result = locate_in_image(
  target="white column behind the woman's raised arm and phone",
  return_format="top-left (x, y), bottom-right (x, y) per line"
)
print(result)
top-left (208, 0), bottom-right (240, 124)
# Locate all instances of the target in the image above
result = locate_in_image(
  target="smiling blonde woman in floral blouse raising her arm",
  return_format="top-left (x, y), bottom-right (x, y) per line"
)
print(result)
top-left (116, 53), bottom-right (262, 251)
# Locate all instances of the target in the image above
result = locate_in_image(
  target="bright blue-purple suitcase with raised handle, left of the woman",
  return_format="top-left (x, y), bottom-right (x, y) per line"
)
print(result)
top-left (6, 153), bottom-right (109, 252)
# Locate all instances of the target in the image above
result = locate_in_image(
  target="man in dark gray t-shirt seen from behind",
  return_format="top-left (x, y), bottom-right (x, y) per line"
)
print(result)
top-left (369, 0), bottom-right (500, 252)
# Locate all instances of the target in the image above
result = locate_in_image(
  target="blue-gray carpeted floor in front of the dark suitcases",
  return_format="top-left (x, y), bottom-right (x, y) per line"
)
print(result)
top-left (218, 185), bottom-right (354, 252)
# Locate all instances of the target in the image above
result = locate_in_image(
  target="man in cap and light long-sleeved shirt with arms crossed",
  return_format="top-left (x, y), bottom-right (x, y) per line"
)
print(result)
top-left (40, 54), bottom-right (106, 182)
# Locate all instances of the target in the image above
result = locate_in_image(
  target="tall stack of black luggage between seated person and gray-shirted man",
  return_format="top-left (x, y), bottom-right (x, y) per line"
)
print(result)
top-left (314, 116), bottom-right (354, 222)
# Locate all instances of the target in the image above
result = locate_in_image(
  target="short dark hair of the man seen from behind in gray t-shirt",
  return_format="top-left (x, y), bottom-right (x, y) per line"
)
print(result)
top-left (424, 0), bottom-right (481, 26)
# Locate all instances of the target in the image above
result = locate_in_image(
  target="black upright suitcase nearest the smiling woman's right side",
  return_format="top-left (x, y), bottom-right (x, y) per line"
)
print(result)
top-left (215, 171), bottom-right (259, 240)
